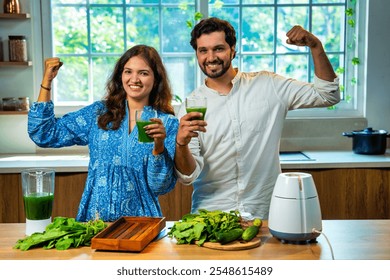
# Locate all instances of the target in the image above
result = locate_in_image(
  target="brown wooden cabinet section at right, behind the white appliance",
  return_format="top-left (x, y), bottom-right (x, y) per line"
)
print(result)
top-left (283, 168), bottom-right (390, 219)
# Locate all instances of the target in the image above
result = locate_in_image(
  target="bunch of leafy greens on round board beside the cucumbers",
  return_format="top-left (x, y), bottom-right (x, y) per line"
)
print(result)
top-left (168, 209), bottom-right (242, 246)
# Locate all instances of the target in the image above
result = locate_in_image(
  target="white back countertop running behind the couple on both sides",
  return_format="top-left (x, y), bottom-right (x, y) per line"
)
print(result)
top-left (0, 150), bottom-right (390, 173)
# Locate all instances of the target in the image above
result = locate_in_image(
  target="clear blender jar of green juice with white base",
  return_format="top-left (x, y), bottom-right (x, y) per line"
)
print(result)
top-left (21, 168), bottom-right (55, 235)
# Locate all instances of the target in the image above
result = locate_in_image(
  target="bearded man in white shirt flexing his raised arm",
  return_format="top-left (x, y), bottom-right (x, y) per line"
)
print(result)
top-left (175, 18), bottom-right (340, 219)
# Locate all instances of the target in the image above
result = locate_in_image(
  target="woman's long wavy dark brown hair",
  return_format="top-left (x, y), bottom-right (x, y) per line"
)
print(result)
top-left (98, 45), bottom-right (174, 130)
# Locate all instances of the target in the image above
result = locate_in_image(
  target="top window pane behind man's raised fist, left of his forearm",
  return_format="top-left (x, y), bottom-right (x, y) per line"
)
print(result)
top-left (277, 7), bottom-right (309, 53)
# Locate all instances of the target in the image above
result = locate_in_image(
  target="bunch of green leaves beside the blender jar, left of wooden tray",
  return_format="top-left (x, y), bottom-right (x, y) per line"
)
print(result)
top-left (14, 217), bottom-right (107, 251)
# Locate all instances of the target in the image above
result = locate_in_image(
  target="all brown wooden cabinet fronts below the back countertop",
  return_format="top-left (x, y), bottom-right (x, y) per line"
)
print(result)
top-left (0, 168), bottom-right (390, 223)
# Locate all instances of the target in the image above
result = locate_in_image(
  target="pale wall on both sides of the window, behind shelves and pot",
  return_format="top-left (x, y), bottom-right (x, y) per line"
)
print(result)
top-left (0, 0), bottom-right (390, 153)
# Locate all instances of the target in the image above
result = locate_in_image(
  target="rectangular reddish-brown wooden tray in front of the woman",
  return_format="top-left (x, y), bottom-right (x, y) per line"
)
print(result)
top-left (91, 217), bottom-right (165, 252)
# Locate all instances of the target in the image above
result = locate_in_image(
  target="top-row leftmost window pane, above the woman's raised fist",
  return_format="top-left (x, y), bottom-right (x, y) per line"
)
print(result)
top-left (52, 7), bottom-right (88, 54)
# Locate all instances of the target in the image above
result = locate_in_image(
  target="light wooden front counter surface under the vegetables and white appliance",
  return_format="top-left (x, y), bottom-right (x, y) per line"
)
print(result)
top-left (0, 220), bottom-right (390, 260)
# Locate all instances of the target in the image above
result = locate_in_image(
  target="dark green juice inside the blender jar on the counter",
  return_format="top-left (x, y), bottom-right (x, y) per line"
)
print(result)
top-left (23, 193), bottom-right (54, 220)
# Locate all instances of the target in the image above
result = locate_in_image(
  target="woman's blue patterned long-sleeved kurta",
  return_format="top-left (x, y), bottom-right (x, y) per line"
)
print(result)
top-left (28, 101), bottom-right (178, 221)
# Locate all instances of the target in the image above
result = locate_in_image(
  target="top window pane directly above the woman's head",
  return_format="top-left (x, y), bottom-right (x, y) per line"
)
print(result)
top-left (127, 7), bottom-right (160, 51)
